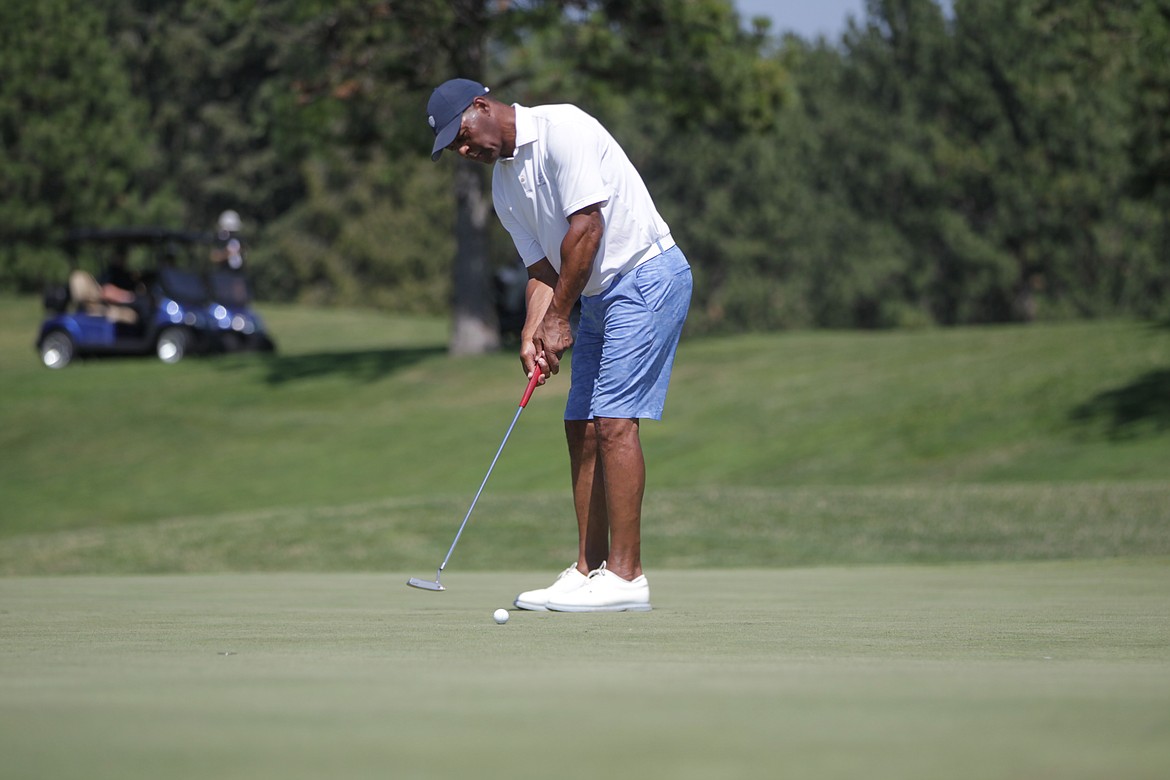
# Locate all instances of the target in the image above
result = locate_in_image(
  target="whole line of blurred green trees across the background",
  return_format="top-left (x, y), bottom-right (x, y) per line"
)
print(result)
top-left (0, 0), bottom-right (1170, 343)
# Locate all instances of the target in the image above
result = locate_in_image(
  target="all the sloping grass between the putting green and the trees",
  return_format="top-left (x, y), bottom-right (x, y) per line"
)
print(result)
top-left (0, 298), bottom-right (1170, 573)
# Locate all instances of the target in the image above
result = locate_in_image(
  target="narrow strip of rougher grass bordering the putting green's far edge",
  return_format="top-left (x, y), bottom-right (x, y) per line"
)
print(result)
top-left (0, 482), bottom-right (1170, 575)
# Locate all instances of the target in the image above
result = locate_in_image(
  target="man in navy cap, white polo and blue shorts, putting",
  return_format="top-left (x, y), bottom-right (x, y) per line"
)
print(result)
top-left (427, 78), bottom-right (691, 612)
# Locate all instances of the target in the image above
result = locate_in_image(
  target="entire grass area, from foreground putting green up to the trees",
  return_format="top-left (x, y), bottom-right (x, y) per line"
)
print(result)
top-left (0, 298), bottom-right (1170, 780)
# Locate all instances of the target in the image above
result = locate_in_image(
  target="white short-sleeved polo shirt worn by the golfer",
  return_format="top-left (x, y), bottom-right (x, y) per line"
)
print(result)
top-left (491, 105), bottom-right (674, 295)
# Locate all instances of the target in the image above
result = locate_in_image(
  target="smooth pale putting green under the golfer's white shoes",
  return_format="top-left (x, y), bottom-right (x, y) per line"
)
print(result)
top-left (0, 558), bottom-right (1170, 780)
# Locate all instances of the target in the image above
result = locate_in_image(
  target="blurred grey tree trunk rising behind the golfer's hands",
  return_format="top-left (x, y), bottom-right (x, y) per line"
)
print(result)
top-left (449, 159), bottom-right (500, 356)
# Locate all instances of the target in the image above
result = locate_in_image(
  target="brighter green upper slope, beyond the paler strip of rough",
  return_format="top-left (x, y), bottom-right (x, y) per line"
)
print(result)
top-left (0, 299), bottom-right (1170, 558)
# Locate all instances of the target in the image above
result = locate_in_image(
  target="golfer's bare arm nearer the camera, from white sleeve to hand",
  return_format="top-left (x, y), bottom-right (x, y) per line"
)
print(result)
top-left (532, 203), bottom-right (605, 374)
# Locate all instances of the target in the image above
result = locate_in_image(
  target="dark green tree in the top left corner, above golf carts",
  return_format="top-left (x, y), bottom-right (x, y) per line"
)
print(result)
top-left (0, 0), bottom-right (177, 290)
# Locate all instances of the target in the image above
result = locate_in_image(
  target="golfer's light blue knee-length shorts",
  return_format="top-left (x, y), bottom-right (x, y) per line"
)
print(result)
top-left (565, 247), bottom-right (691, 420)
